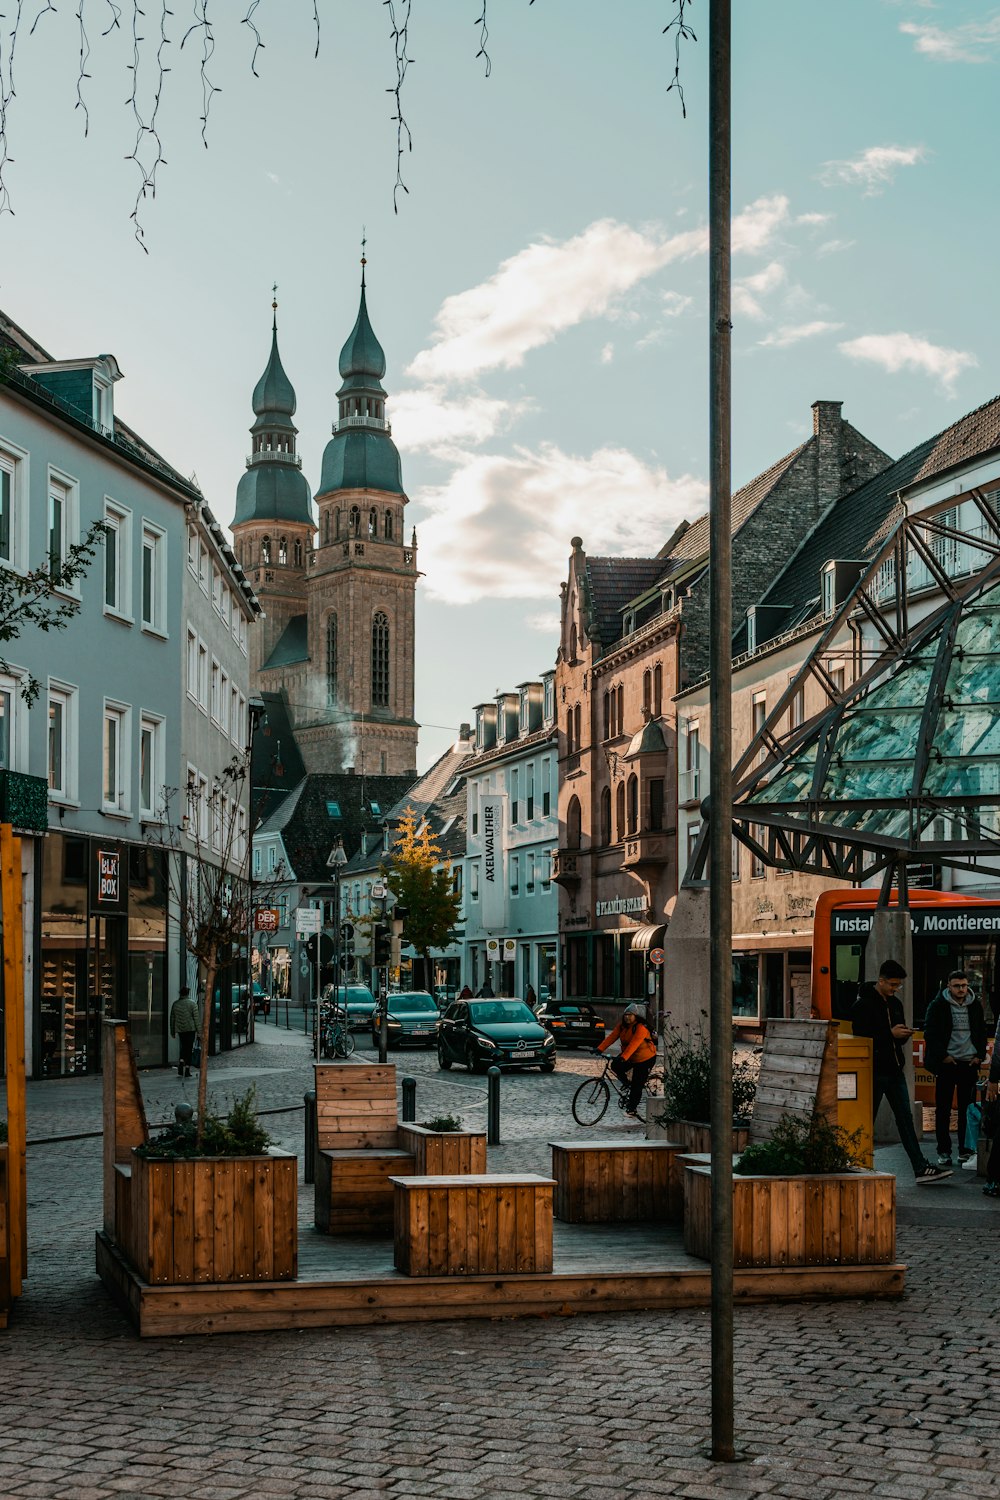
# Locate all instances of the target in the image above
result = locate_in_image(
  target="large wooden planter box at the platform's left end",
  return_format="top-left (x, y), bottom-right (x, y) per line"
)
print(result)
top-left (115, 1151), bottom-right (298, 1286)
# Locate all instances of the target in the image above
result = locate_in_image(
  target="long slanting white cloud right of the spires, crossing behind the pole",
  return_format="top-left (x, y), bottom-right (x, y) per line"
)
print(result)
top-left (408, 194), bottom-right (789, 384)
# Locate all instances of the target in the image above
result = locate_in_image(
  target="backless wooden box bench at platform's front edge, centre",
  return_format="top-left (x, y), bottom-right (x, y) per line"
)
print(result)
top-left (391, 1173), bottom-right (555, 1277)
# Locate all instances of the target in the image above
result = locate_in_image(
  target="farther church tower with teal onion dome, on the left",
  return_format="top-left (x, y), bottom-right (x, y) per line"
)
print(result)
top-left (232, 303), bottom-right (316, 681)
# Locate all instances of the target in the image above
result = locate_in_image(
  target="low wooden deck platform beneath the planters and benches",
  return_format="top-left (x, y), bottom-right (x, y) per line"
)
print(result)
top-left (97, 1199), bottom-right (904, 1338)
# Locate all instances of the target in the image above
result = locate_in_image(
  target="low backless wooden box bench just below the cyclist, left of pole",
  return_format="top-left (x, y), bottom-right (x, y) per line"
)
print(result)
top-left (552, 1140), bottom-right (682, 1224)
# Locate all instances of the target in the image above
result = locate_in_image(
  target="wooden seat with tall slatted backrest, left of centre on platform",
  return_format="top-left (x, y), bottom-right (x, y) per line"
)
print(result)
top-left (315, 1062), bottom-right (415, 1235)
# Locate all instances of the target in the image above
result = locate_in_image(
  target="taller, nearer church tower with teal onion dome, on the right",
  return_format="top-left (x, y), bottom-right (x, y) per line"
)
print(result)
top-left (295, 258), bottom-right (418, 776)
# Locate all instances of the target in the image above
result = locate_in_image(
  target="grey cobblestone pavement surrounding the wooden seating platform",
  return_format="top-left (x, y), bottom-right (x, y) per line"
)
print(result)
top-left (0, 1028), bottom-right (1000, 1500)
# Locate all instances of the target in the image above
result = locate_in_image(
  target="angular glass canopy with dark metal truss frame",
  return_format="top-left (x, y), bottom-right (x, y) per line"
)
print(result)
top-left (707, 495), bottom-right (1000, 881)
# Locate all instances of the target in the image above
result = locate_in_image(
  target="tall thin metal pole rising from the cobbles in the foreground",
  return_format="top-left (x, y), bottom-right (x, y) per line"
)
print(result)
top-left (709, 0), bottom-right (736, 1463)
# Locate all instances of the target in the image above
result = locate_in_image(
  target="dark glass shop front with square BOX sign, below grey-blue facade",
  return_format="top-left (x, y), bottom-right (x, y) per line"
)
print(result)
top-left (31, 833), bottom-right (168, 1079)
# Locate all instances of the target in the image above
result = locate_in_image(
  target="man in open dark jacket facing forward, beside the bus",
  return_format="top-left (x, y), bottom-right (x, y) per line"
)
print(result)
top-left (924, 969), bottom-right (987, 1167)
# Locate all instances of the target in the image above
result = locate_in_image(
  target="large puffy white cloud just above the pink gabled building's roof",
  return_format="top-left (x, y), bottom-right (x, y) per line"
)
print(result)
top-left (414, 446), bottom-right (708, 605)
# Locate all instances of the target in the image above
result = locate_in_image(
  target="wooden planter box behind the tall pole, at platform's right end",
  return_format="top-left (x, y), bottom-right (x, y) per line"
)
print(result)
top-left (684, 1167), bottom-right (897, 1269)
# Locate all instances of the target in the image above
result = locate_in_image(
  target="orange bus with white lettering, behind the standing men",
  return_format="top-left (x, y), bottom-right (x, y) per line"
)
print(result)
top-left (813, 888), bottom-right (1000, 1100)
